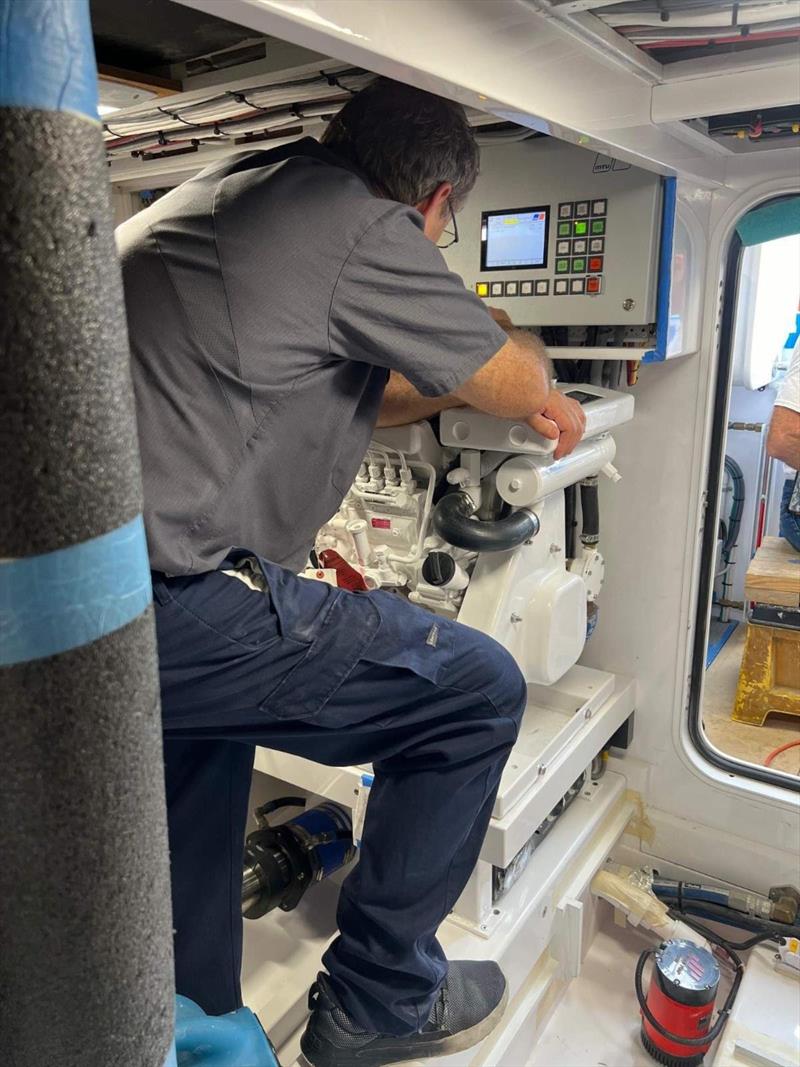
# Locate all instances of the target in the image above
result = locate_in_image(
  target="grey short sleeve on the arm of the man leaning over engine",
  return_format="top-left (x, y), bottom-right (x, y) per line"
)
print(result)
top-left (329, 205), bottom-right (508, 397)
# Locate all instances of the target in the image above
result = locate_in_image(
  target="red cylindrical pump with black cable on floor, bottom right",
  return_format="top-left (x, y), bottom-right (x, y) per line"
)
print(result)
top-left (636, 940), bottom-right (741, 1067)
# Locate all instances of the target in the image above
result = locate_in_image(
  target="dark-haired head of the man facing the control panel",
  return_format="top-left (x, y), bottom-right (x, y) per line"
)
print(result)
top-left (322, 78), bottom-right (479, 241)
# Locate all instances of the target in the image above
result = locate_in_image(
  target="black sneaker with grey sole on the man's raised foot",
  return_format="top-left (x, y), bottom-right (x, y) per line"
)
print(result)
top-left (300, 960), bottom-right (508, 1067)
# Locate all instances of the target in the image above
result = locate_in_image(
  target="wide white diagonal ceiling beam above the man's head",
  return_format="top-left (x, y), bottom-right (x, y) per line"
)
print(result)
top-left (174, 0), bottom-right (722, 186)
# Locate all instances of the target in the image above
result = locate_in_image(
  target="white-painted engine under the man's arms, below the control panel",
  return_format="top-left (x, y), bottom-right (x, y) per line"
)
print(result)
top-left (309, 385), bottom-right (633, 685)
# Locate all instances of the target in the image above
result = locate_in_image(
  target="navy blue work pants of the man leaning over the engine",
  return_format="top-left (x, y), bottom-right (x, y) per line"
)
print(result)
top-left (154, 560), bottom-right (525, 1034)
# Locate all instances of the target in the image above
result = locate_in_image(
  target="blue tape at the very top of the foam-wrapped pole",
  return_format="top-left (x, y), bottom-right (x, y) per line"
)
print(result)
top-left (0, 0), bottom-right (97, 120)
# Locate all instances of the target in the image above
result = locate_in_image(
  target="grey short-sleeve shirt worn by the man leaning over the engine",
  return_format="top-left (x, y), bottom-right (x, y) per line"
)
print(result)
top-left (117, 140), bottom-right (507, 574)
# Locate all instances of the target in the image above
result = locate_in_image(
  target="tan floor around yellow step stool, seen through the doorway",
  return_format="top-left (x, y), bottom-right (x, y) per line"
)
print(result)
top-left (703, 624), bottom-right (800, 775)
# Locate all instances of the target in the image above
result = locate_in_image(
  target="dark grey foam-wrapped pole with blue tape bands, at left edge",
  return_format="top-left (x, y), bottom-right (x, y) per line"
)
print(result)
top-left (0, 0), bottom-right (175, 1067)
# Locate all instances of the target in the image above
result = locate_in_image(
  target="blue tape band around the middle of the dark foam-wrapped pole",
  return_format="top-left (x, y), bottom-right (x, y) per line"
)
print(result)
top-left (0, 515), bottom-right (153, 667)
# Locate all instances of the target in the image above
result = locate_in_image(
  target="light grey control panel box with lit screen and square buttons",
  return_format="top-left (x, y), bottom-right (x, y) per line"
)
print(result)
top-left (444, 138), bottom-right (661, 325)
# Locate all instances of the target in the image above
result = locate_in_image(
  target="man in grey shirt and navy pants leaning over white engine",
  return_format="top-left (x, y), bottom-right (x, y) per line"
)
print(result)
top-left (118, 81), bottom-right (583, 1067)
